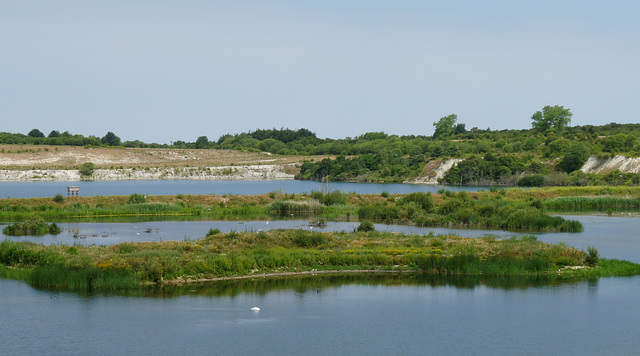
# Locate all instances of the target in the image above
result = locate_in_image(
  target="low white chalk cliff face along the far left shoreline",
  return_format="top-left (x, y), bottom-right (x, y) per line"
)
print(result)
top-left (0, 165), bottom-right (294, 182)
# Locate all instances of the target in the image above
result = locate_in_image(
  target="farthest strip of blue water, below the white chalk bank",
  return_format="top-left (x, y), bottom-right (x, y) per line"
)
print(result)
top-left (0, 180), bottom-right (485, 198)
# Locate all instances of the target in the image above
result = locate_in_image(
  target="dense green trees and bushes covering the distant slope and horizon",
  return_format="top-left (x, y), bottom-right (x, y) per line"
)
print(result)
top-left (0, 121), bottom-right (640, 186)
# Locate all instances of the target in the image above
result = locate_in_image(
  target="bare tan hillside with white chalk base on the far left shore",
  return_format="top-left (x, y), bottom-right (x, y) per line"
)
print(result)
top-left (0, 145), bottom-right (326, 181)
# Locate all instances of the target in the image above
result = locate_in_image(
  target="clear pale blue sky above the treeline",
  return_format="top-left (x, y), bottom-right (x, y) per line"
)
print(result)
top-left (0, 0), bottom-right (640, 143)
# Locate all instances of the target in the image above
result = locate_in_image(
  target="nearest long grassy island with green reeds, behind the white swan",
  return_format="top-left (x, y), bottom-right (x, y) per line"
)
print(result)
top-left (0, 230), bottom-right (640, 290)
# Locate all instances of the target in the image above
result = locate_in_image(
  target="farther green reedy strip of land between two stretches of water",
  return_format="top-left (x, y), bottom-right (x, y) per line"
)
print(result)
top-left (0, 188), bottom-right (616, 232)
